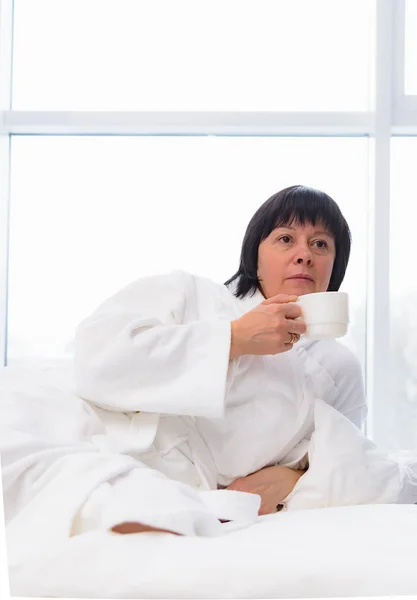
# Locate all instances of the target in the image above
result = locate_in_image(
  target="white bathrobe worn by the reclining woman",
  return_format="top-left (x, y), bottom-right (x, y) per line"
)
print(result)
top-left (0, 272), bottom-right (366, 572)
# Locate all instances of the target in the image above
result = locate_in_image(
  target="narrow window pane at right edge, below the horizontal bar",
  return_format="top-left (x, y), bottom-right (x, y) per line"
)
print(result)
top-left (388, 138), bottom-right (417, 451)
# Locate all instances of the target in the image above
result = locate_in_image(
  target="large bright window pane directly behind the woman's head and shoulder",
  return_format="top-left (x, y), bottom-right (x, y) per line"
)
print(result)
top-left (8, 136), bottom-right (367, 362)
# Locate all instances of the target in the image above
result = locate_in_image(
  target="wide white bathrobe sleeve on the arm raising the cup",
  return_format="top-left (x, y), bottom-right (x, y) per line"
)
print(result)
top-left (75, 272), bottom-right (231, 418)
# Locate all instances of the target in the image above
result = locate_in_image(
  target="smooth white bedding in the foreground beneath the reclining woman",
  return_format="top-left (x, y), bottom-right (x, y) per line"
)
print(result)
top-left (10, 505), bottom-right (417, 598)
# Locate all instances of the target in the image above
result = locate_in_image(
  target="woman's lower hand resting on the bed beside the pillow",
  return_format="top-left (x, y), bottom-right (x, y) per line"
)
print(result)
top-left (226, 465), bottom-right (304, 515)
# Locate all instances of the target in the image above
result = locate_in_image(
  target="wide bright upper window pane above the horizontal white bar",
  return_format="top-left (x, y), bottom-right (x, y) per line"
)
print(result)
top-left (13, 0), bottom-right (375, 111)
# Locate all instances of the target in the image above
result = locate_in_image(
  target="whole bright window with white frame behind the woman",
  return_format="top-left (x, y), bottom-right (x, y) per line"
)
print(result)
top-left (0, 0), bottom-right (417, 450)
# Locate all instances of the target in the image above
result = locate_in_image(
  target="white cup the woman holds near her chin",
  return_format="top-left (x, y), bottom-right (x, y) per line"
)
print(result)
top-left (297, 292), bottom-right (349, 340)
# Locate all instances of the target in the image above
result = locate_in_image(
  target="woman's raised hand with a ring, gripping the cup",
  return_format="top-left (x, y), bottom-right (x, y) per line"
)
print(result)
top-left (230, 294), bottom-right (306, 360)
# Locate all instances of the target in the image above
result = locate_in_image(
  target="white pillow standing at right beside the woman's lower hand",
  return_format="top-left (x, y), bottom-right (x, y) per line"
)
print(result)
top-left (284, 399), bottom-right (403, 510)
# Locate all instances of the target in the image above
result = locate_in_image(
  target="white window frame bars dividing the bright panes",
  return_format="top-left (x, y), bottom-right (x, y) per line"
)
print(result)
top-left (0, 0), bottom-right (410, 446)
